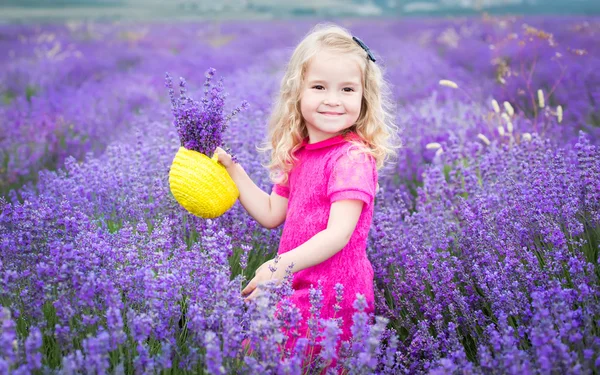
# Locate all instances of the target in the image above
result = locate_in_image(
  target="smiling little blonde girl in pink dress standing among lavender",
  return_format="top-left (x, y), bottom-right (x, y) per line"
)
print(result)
top-left (217, 25), bottom-right (397, 368)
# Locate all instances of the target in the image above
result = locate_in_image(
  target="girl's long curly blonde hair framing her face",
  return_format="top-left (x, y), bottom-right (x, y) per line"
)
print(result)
top-left (258, 24), bottom-right (401, 184)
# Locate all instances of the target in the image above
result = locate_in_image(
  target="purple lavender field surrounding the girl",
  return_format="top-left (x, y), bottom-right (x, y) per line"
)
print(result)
top-left (0, 16), bottom-right (600, 374)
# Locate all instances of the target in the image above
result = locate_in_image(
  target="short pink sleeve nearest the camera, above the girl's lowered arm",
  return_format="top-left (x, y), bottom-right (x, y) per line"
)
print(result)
top-left (327, 150), bottom-right (377, 205)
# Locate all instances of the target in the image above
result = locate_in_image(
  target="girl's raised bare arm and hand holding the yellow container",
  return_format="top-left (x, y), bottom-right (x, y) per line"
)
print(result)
top-left (216, 148), bottom-right (288, 229)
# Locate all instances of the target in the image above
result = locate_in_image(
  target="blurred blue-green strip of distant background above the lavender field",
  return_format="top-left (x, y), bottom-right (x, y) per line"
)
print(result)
top-left (0, 0), bottom-right (600, 22)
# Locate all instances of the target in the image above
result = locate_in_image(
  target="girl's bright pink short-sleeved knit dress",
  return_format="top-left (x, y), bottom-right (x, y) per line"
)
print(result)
top-left (273, 132), bottom-right (377, 365)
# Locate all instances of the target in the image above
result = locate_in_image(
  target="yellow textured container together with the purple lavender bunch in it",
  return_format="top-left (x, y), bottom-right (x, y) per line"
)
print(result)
top-left (166, 68), bottom-right (248, 218)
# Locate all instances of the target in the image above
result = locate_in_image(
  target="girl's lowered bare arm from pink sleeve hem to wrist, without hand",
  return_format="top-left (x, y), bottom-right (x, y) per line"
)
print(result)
top-left (277, 199), bottom-right (364, 272)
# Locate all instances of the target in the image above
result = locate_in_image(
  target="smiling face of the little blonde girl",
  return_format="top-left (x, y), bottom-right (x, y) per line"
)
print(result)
top-left (300, 51), bottom-right (363, 143)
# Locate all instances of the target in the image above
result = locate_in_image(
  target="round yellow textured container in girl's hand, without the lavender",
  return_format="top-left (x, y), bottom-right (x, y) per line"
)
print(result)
top-left (169, 147), bottom-right (240, 219)
